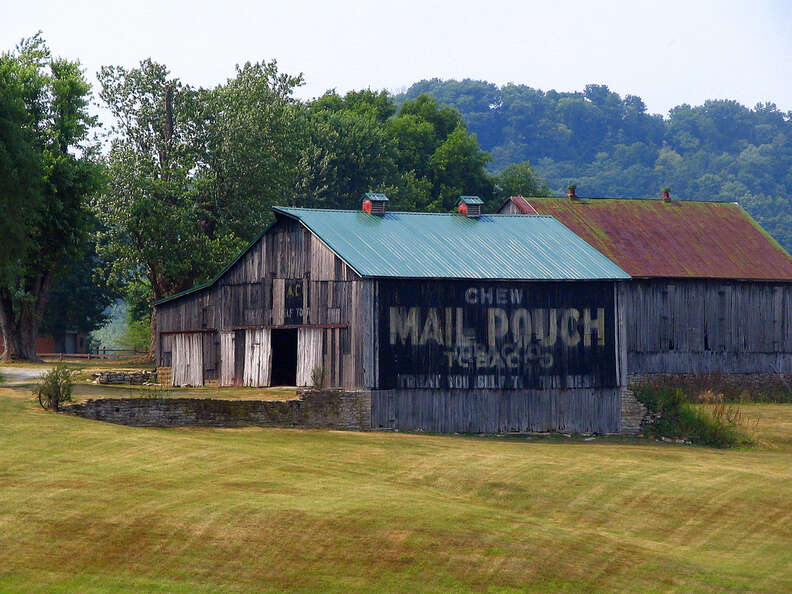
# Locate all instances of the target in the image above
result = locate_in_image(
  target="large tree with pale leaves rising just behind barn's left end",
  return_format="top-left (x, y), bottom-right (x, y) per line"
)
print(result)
top-left (94, 60), bottom-right (302, 346)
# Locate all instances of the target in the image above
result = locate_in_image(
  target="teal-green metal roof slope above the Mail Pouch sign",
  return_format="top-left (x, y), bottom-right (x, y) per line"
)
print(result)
top-left (273, 206), bottom-right (630, 280)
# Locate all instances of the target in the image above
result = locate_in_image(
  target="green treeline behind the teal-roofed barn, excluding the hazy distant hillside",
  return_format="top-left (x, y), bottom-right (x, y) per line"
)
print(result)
top-left (0, 35), bottom-right (547, 358)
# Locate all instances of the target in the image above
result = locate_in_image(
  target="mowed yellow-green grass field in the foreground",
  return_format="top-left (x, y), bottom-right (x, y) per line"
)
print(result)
top-left (0, 372), bottom-right (792, 592)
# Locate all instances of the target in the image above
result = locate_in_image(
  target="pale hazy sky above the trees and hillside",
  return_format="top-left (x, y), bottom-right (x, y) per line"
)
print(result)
top-left (6, 0), bottom-right (792, 114)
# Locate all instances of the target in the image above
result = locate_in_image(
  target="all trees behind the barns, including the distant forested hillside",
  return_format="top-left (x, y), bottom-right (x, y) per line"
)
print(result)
top-left (6, 35), bottom-right (792, 358)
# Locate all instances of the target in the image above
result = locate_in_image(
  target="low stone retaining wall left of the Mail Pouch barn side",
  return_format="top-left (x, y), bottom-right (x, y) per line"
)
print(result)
top-left (59, 390), bottom-right (371, 431)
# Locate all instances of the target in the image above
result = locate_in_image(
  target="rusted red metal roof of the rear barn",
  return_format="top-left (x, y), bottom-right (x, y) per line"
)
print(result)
top-left (504, 198), bottom-right (792, 281)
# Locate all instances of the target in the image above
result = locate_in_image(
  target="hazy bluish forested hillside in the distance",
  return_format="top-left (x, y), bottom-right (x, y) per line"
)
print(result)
top-left (396, 79), bottom-right (792, 251)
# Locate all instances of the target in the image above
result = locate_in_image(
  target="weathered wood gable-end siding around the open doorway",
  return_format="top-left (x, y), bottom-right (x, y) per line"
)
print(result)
top-left (156, 218), bottom-right (373, 388)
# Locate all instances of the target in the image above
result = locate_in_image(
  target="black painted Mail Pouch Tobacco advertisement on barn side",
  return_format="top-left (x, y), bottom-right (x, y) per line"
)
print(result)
top-left (378, 281), bottom-right (617, 390)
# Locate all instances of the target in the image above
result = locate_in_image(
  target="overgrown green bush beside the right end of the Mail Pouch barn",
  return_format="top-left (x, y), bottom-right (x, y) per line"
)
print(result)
top-left (636, 386), bottom-right (758, 448)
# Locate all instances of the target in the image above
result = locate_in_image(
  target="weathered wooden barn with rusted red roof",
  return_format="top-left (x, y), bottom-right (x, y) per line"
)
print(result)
top-left (500, 189), bottom-right (792, 374)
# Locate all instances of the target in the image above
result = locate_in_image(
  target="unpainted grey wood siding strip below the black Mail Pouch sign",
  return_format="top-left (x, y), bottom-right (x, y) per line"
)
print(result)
top-left (371, 388), bottom-right (621, 433)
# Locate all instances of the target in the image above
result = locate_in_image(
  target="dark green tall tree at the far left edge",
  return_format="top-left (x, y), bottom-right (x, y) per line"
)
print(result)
top-left (0, 35), bottom-right (99, 360)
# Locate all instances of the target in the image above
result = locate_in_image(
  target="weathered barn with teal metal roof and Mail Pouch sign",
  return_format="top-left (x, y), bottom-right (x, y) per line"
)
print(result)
top-left (155, 195), bottom-right (629, 433)
